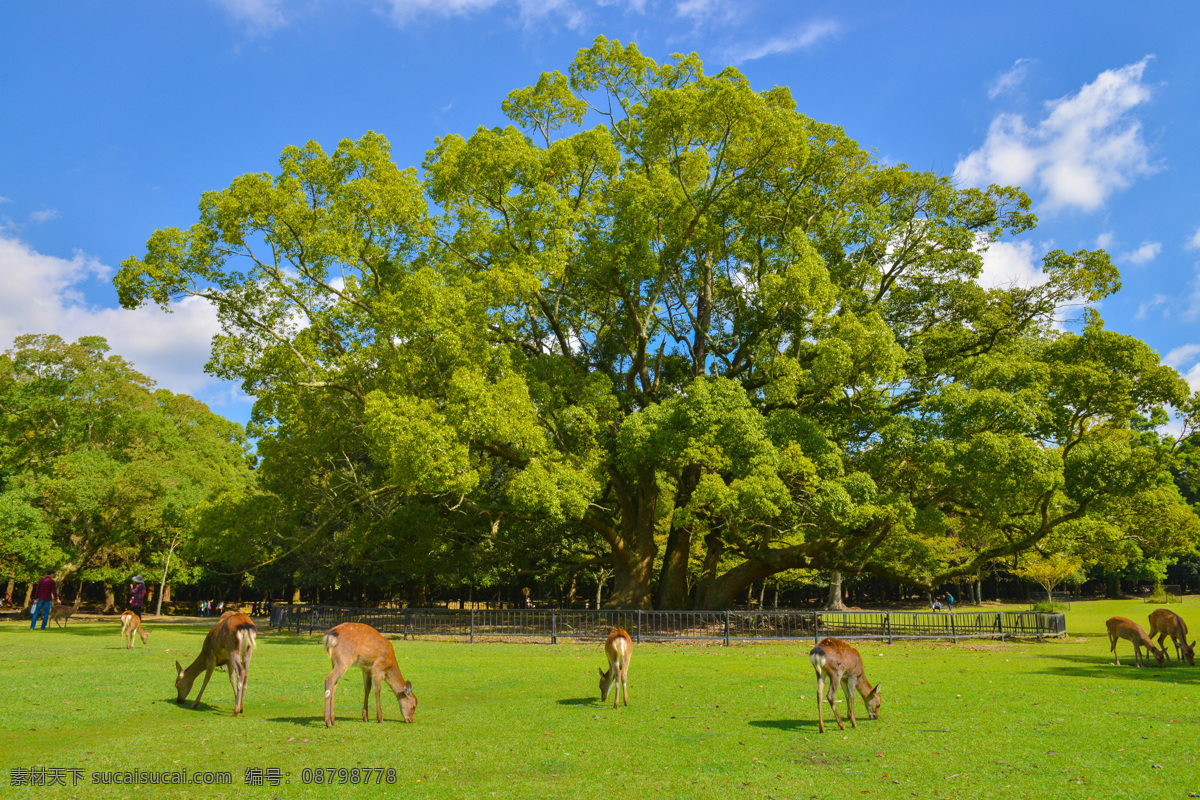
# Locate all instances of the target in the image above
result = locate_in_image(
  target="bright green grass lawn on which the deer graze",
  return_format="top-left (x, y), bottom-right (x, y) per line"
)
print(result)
top-left (0, 597), bottom-right (1200, 800)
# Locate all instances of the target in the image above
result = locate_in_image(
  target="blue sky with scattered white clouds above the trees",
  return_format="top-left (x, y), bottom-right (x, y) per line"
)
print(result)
top-left (0, 0), bottom-right (1200, 431)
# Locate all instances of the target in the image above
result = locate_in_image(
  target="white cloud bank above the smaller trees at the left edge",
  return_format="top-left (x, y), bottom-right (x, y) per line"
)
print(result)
top-left (0, 235), bottom-right (236, 403)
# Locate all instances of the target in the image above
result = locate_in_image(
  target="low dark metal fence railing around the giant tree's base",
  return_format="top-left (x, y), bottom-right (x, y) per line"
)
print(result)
top-left (271, 604), bottom-right (1067, 646)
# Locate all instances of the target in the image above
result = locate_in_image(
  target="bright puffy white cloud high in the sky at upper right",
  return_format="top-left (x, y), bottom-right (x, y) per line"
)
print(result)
top-left (955, 56), bottom-right (1154, 211)
